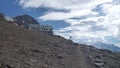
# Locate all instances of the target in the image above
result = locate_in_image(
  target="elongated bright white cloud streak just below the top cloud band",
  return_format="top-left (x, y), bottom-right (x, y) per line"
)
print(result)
top-left (39, 9), bottom-right (97, 20)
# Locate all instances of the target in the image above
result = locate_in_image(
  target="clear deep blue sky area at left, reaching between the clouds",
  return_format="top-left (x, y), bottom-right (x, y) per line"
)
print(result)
top-left (0, 0), bottom-right (69, 29)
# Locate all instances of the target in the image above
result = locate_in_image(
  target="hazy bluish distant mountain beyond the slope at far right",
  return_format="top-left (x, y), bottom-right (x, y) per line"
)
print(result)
top-left (93, 42), bottom-right (120, 52)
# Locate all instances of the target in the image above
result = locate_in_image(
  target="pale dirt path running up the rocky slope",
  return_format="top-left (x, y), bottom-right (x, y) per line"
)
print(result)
top-left (71, 46), bottom-right (89, 68)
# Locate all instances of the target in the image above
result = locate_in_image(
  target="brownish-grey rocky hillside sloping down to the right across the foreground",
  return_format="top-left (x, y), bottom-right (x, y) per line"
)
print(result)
top-left (0, 15), bottom-right (120, 68)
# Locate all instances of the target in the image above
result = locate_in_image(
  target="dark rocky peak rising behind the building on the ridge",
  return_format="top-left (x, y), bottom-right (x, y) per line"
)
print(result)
top-left (14, 14), bottom-right (39, 28)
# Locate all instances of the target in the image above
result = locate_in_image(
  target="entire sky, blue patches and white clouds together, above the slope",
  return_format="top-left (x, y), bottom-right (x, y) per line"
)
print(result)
top-left (0, 0), bottom-right (120, 47)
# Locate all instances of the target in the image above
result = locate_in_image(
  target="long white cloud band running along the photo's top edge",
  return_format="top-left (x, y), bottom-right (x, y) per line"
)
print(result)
top-left (19, 0), bottom-right (112, 10)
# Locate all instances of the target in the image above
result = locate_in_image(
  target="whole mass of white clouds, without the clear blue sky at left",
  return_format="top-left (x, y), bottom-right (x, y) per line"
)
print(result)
top-left (19, 0), bottom-right (120, 46)
